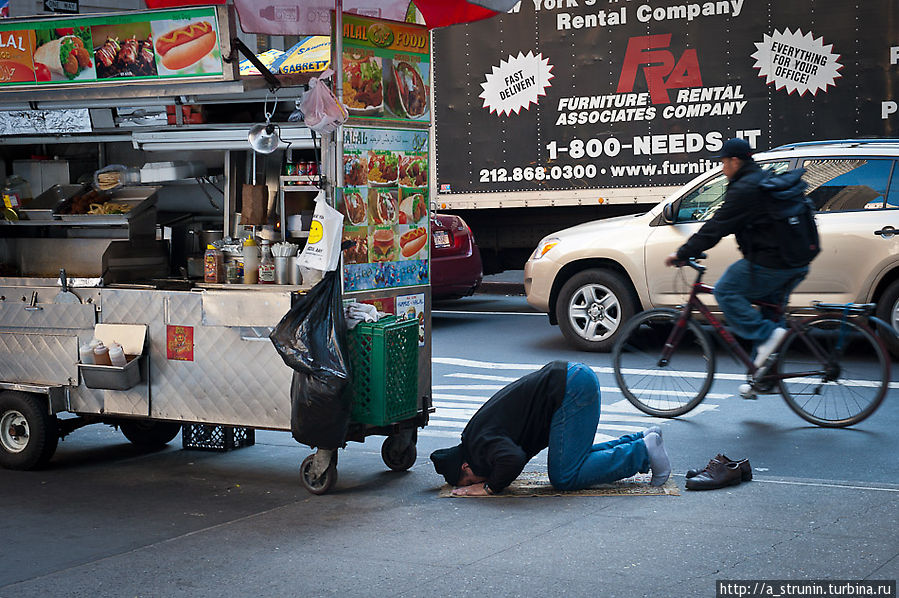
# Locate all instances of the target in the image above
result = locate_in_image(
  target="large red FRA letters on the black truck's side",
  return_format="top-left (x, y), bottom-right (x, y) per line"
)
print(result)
top-left (618, 33), bottom-right (702, 104)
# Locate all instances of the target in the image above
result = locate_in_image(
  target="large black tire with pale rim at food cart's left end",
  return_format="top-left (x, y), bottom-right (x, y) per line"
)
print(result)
top-left (0, 391), bottom-right (59, 469)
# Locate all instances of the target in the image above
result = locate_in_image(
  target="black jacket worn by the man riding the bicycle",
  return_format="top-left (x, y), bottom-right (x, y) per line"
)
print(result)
top-left (677, 160), bottom-right (790, 270)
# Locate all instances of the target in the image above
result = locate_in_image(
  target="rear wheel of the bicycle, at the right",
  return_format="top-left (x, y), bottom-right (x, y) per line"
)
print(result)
top-left (776, 316), bottom-right (890, 428)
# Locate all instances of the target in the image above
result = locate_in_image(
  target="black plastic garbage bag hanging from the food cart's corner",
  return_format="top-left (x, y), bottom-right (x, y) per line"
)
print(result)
top-left (269, 271), bottom-right (352, 449)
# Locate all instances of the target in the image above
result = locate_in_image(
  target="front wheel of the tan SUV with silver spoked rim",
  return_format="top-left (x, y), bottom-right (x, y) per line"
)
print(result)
top-left (556, 268), bottom-right (636, 351)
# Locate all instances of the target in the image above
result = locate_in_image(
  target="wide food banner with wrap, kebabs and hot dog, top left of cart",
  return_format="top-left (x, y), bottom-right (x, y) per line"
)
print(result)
top-left (0, 7), bottom-right (223, 90)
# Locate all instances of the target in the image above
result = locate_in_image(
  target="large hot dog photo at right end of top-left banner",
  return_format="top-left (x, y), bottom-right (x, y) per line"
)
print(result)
top-left (153, 17), bottom-right (222, 75)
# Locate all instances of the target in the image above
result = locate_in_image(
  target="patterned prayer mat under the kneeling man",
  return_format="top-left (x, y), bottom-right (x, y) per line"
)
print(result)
top-left (438, 471), bottom-right (680, 498)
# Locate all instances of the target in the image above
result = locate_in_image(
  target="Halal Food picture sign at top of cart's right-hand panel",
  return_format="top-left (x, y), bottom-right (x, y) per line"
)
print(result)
top-left (342, 14), bottom-right (431, 123)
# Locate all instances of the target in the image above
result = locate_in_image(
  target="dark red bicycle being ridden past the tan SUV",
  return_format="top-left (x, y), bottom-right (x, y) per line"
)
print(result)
top-left (612, 259), bottom-right (894, 428)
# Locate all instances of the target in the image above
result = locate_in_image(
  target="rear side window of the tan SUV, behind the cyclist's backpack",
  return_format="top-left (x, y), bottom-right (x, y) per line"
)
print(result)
top-left (802, 158), bottom-right (893, 212)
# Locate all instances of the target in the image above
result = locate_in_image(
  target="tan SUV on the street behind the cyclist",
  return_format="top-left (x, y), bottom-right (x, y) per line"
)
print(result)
top-left (524, 140), bottom-right (899, 351)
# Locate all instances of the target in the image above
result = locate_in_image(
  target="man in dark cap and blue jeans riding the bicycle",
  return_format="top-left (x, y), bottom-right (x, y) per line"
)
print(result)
top-left (665, 138), bottom-right (808, 367)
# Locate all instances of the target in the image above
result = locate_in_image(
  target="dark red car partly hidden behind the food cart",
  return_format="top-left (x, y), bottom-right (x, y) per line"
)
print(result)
top-left (431, 214), bottom-right (484, 300)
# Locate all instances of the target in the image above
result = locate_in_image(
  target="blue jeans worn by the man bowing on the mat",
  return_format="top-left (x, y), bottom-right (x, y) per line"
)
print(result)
top-left (548, 363), bottom-right (649, 490)
